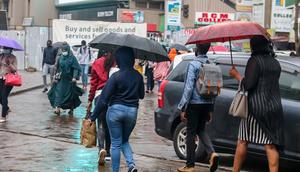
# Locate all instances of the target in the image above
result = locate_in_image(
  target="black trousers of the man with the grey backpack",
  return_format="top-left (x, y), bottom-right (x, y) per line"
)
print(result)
top-left (186, 104), bottom-right (215, 167)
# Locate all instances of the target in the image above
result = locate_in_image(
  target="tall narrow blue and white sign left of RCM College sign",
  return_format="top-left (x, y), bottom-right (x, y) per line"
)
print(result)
top-left (167, 0), bottom-right (181, 31)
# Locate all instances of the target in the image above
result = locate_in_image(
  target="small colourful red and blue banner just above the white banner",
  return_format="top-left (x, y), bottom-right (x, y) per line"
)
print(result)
top-left (120, 11), bottom-right (144, 23)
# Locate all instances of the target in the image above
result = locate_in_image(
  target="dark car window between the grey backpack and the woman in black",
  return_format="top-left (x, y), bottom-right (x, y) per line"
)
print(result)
top-left (218, 64), bottom-right (245, 90)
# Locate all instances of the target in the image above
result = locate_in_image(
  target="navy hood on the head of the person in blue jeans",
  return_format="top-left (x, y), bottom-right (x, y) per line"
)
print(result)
top-left (115, 47), bottom-right (134, 69)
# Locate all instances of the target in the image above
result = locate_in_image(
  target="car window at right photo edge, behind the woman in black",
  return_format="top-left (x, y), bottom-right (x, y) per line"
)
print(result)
top-left (279, 71), bottom-right (300, 101)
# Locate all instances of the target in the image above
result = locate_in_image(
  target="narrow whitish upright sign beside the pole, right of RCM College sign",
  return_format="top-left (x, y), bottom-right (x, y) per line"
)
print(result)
top-left (252, 0), bottom-right (265, 27)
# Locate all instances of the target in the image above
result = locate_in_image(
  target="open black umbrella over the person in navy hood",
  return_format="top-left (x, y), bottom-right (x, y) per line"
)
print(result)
top-left (89, 33), bottom-right (169, 62)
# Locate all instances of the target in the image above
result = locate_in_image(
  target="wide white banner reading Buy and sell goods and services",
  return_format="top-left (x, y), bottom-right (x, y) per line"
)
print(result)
top-left (53, 19), bottom-right (147, 45)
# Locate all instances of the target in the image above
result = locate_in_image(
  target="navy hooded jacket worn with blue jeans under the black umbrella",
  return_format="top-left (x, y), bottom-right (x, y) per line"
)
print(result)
top-left (90, 47), bottom-right (145, 121)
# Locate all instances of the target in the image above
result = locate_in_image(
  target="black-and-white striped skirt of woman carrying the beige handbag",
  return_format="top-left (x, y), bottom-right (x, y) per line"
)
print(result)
top-left (238, 115), bottom-right (272, 145)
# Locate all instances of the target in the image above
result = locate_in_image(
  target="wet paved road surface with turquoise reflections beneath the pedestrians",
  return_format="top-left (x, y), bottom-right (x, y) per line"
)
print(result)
top-left (0, 90), bottom-right (296, 172)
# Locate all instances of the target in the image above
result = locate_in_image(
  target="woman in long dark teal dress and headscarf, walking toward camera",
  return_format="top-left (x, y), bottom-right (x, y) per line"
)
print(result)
top-left (48, 43), bottom-right (83, 115)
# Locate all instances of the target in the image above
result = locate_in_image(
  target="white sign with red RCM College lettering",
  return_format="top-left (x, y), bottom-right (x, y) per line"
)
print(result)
top-left (195, 12), bottom-right (235, 25)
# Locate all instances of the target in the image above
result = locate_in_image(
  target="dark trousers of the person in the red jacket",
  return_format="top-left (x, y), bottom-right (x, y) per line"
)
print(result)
top-left (95, 96), bottom-right (111, 155)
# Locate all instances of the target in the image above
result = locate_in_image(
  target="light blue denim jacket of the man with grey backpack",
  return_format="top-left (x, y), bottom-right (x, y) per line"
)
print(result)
top-left (177, 55), bottom-right (214, 111)
